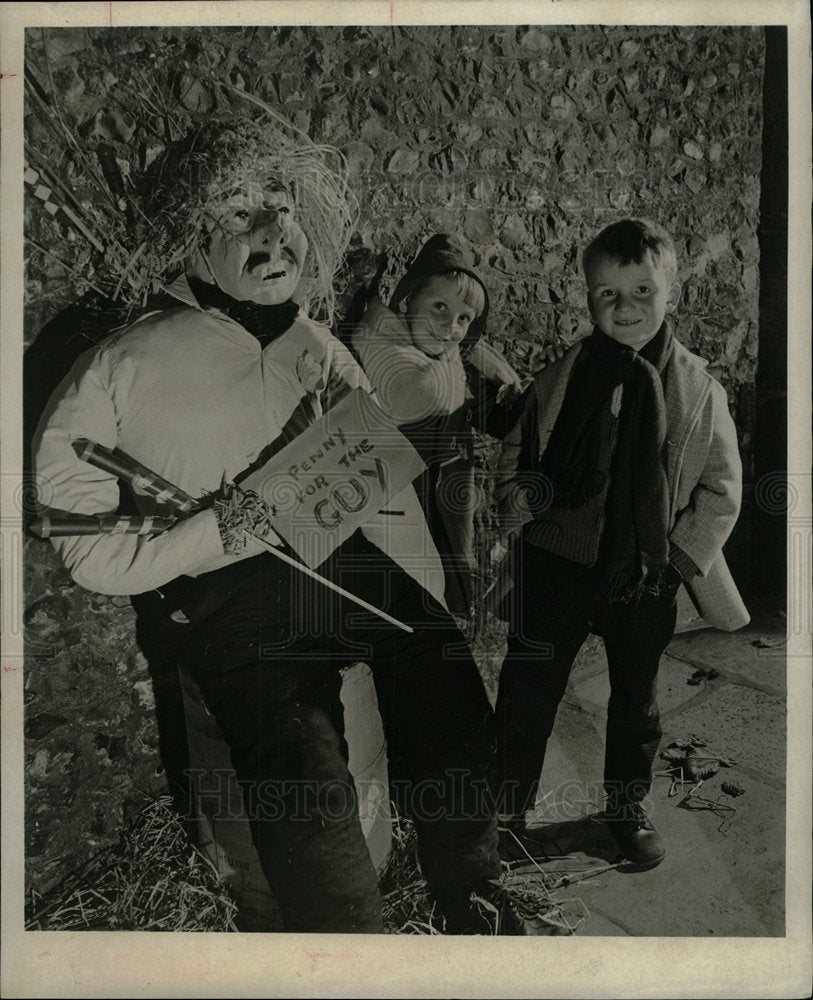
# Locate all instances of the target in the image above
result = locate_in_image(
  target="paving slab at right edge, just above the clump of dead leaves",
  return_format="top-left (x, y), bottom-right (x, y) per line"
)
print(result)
top-left (664, 684), bottom-right (786, 782)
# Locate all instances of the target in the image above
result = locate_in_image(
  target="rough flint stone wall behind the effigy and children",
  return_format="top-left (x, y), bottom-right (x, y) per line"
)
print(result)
top-left (26, 26), bottom-right (763, 891)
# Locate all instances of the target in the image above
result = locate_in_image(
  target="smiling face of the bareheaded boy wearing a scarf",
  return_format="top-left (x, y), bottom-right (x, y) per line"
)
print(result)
top-left (587, 254), bottom-right (680, 351)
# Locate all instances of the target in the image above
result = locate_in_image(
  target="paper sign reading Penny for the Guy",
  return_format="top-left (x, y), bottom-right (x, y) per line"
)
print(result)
top-left (240, 389), bottom-right (426, 569)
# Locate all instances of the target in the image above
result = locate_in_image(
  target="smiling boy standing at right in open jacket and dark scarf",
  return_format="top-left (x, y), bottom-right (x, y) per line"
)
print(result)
top-left (497, 219), bottom-right (749, 867)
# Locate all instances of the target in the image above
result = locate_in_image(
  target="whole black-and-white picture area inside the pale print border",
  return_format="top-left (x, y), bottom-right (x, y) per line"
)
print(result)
top-left (3, 7), bottom-right (810, 995)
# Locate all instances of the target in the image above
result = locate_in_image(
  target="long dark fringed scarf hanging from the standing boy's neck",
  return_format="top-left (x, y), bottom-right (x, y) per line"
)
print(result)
top-left (543, 323), bottom-right (673, 600)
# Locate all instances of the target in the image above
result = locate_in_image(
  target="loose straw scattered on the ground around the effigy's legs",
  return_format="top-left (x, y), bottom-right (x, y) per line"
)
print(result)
top-left (25, 796), bottom-right (592, 935)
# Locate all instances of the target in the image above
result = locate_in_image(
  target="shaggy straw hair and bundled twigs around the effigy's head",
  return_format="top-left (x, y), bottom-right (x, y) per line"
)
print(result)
top-left (26, 39), bottom-right (358, 325)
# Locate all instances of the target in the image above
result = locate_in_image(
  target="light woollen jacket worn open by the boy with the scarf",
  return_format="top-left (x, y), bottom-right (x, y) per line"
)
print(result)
top-left (499, 341), bottom-right (750, 631)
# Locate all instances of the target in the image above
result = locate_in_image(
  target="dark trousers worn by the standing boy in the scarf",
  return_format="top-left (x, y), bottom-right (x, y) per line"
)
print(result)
top-left (496, 542), bottom-right (676, 815)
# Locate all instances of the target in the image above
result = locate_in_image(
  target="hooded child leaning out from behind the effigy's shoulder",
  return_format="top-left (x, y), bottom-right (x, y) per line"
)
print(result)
top-left (351, 233), bottom-right (523, 614)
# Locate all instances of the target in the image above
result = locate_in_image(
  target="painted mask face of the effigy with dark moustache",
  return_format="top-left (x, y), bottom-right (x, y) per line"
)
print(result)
top-left (203, 180), bottom-right (308, 305)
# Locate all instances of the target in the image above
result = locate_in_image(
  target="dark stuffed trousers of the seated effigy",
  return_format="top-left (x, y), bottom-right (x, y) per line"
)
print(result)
top-left (142, 533), bottom-right (500, 932)
